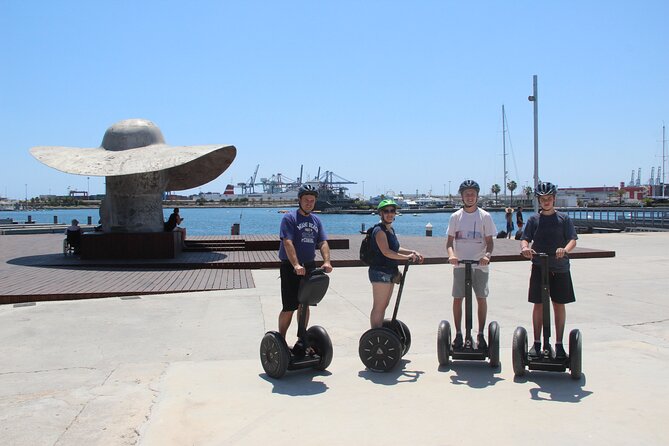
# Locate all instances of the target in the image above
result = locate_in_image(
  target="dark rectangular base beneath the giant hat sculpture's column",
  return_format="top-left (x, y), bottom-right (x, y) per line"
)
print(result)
top-left (81, 231), bottom-right (182, 260)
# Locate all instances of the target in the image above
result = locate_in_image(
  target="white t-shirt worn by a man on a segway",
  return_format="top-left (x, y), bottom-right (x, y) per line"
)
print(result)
top-left (447, 208), bottom-right (497, 266)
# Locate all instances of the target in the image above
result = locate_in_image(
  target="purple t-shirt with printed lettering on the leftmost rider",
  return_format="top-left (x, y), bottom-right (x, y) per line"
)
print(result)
top-left (279, 210), bottom-right (328, 264)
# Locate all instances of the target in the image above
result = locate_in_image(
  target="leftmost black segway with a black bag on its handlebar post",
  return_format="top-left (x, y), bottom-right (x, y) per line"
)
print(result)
top-left (260, 268), bottom-right (332, 378)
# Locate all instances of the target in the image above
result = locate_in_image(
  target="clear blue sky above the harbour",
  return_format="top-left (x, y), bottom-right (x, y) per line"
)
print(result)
top-left (0, 0), bottom-right (669, 199)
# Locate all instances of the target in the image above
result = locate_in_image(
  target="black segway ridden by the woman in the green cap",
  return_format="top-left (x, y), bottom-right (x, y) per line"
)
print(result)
top-left (358, 262), bottom-right (411, 372)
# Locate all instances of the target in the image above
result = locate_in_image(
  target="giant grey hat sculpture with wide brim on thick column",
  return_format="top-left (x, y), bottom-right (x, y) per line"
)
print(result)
top-left (30, 119), bottom-right (237, 232)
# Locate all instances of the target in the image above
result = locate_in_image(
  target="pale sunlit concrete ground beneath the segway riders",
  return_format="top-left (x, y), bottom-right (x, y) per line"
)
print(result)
top-left (0, 233), bottom-right (669, 446)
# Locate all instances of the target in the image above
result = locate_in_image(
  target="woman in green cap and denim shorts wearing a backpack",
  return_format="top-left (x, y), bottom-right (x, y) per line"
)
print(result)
top-left (368, 200), bottom-right (423, 328)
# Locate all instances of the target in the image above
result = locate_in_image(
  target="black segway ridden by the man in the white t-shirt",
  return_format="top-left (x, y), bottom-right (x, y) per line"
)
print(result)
top-left (437, 260), bottom-right (499, 367)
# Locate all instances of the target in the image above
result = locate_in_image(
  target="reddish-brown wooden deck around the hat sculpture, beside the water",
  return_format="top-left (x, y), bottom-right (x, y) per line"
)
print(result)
top-left (0, 234), bottom-right (615, 304)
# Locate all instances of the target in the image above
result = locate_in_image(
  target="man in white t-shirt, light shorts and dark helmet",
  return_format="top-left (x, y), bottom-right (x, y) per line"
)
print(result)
top-left (446, 180), bottom-right (497, 350)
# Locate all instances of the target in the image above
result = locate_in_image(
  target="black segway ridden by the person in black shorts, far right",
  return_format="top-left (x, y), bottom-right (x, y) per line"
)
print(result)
top-left (512, 253), bottom-right (583, 379)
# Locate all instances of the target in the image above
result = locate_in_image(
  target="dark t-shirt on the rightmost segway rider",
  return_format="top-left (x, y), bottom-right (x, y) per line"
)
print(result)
top-left (522, 212), bottom-right (578, 272)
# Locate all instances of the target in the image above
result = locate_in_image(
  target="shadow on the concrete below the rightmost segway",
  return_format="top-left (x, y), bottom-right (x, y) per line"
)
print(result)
top-left (513, 370), bottom-right (592, 403)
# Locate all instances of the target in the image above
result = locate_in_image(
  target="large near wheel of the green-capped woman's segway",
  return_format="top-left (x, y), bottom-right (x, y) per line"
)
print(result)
top-left (358, 328), bottom-right (402, 372)
